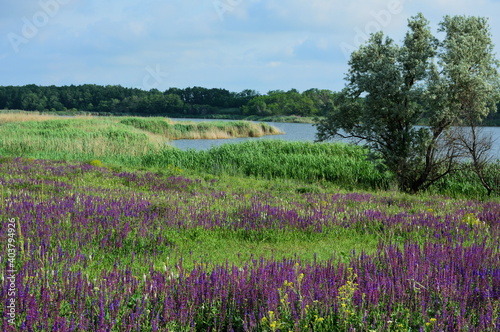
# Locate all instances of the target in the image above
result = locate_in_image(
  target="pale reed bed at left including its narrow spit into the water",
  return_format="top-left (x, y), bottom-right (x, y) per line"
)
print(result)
top-left (0, 113), bottom-right (281, 164)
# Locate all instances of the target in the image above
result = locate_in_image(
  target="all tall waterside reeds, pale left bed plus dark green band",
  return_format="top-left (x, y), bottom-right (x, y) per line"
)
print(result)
top-left (0, 116), bottom-right (388, 189)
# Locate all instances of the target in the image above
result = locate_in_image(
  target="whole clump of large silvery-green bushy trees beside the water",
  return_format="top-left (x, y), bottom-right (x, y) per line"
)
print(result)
top-left (317, 14), bottom-right (499, 192)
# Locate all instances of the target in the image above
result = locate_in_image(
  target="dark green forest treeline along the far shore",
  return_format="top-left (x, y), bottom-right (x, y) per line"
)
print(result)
top-left (0, 84), bottom-right (337, 117)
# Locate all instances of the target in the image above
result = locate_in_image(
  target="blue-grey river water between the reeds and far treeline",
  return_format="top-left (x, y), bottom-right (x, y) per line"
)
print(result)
top-left (170, 119), bottom-right (500, 158)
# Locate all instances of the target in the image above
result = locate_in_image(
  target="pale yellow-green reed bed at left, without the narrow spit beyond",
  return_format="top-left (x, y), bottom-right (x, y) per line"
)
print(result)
top-left (0, 118), bottom-right (164, 160)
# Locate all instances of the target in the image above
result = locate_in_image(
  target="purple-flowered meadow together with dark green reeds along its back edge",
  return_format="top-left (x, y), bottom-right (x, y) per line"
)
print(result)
top-left (0, 113), bottom-right (500, 331)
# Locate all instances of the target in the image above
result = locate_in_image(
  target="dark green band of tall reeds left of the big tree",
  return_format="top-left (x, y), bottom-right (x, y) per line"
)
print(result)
top-left (142, 140), bottom-right (389, 188)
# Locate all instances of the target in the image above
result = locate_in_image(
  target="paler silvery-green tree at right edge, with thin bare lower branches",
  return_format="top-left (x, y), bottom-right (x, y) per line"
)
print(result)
top-left (430, 16), bottom-right (500, 196)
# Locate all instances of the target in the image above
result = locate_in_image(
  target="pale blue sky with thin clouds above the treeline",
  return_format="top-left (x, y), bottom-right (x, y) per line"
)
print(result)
top-left (0, 0), bottom-right (500, 93)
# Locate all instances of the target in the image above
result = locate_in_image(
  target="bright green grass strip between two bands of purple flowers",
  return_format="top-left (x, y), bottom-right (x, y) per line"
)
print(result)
top-left (83, 224), bottom-right (379, 276)
